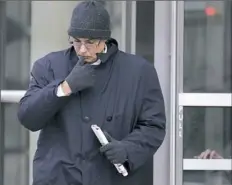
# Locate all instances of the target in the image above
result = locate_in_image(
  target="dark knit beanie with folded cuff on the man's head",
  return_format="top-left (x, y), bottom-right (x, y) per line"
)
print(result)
top-left (68, 0), bottom-right (111, 39)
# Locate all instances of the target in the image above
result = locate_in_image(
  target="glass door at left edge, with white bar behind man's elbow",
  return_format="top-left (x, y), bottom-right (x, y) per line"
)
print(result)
top-left (0, 1), bottom-right (31, 185)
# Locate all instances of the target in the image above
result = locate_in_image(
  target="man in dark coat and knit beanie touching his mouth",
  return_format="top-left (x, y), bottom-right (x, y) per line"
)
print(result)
top-left (18, 1), bottom-right (165, 185)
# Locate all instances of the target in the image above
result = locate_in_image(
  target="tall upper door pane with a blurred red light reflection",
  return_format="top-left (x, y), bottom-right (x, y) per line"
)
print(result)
top-left (183, 1), bottom-right (232, 93)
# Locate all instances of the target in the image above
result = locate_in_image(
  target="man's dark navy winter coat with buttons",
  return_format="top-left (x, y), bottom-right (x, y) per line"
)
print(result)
top-left (18, 41), bottom-right (165, 185)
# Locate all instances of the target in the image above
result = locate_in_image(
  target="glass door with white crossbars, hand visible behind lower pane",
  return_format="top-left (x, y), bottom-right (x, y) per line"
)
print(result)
top-left (175, 1), bottom-right (232, 185)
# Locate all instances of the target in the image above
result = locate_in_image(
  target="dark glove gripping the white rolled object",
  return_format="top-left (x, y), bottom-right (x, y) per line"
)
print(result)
top-left (100, 132), bottom-right (127, 164)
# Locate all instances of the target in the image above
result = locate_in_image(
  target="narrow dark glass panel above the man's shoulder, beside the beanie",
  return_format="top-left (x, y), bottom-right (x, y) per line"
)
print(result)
top-left (136, 1), bottom-right (155, 63)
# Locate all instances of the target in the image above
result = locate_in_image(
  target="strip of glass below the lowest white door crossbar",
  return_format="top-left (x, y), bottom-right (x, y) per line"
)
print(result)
top-left (183, 171), bottom-right (231, 185)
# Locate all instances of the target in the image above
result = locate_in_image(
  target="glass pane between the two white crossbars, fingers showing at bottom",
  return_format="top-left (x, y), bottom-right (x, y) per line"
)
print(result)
top-left (183, 107), bottom-right (232, 159)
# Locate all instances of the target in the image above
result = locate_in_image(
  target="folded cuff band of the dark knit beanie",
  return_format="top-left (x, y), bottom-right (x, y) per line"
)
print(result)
top-left (68, 27), bottom-right (111, 39)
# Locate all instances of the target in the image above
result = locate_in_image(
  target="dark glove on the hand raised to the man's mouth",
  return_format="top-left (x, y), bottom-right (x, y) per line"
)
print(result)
top-left (65, 57), bottom-right (94, 93)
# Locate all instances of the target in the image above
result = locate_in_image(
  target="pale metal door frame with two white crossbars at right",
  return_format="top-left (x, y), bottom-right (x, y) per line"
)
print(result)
top-left (170, 1), bottom-right (232, 185)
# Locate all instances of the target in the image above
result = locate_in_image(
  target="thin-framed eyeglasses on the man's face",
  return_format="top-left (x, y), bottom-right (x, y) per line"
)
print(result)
top-left (69, 37), bottom-right (101, 50)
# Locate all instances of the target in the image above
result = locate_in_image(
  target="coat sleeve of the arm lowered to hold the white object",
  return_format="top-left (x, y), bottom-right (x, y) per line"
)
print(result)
top-left (124, 64), bottom-right (166, 171)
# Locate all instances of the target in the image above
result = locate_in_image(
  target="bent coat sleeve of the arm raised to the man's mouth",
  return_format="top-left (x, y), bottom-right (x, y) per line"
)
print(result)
top-left (18, 58), bottom-right (68, 131)
